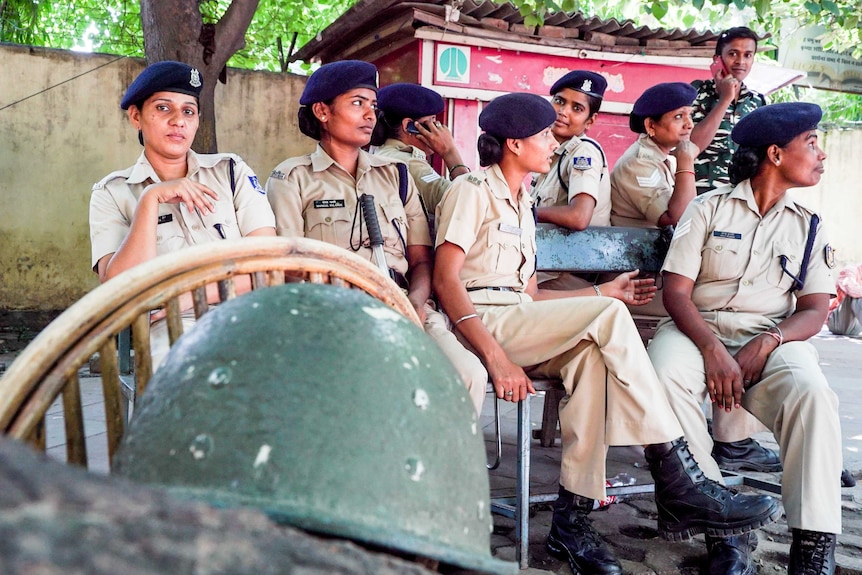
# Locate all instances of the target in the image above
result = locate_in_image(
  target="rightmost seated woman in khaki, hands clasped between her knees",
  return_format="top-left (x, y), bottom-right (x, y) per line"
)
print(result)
top-left (649, 103), bottom-right (841, 575)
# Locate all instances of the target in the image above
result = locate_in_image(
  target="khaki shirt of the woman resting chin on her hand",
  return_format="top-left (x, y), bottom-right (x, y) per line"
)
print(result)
top-left (611, 134), bottom-right (676, 228)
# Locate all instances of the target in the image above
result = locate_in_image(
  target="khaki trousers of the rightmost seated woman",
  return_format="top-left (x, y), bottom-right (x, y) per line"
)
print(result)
top-left (649, 312), bottom-right (842, 533)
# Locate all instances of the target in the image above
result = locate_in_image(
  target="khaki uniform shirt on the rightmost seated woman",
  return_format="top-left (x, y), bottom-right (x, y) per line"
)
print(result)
top-left (662, 180), bottom-right (835, 319)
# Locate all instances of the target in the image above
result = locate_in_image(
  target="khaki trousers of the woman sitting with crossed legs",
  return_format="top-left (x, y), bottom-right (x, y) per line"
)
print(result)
top-left (476, 294), bottom-right (682, 499)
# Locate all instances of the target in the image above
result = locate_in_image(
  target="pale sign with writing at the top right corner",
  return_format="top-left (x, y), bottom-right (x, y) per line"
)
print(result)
top-left (778, 26), bottom-right (862, 94)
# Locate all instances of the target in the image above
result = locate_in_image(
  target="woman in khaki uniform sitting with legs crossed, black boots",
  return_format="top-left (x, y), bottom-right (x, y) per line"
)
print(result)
top-left (434, 93), bottom-right (780, 573)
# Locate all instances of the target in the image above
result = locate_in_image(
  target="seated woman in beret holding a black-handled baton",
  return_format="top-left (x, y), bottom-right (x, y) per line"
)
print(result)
top-left (266, 60), bottom-right (488, 413)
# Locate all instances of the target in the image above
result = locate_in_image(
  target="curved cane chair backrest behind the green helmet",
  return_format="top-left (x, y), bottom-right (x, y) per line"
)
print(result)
top-left (0, 238), bottom-right (421, 467)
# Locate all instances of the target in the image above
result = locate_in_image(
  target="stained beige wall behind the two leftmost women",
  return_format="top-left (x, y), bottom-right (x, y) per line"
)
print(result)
top-left (0, 45), bottom-right (314, 310)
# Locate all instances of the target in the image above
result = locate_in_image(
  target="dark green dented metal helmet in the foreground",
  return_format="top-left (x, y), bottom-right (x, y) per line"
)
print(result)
top-left (114, 284), bottom-right (517, 573)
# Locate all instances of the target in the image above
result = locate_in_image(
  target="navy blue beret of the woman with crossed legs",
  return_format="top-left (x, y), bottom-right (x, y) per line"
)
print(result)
top-left (479, 92), bottom-right (557, 138)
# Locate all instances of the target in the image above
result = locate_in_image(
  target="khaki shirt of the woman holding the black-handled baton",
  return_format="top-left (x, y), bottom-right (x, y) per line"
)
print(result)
top-left (266, 145), bottom-right (432, 275)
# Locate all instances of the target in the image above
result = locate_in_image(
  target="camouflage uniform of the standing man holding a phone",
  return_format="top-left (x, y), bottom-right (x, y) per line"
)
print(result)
top-left (691, 79), bottom-right (766, 195)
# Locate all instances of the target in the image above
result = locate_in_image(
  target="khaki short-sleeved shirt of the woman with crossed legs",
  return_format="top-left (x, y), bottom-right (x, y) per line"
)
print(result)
top-left (436, 164), bottom-right (536, 296)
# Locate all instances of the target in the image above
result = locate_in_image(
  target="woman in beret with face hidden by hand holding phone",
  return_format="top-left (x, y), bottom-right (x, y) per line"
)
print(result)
top-left (371, 83), bottom-right (470, 216)
